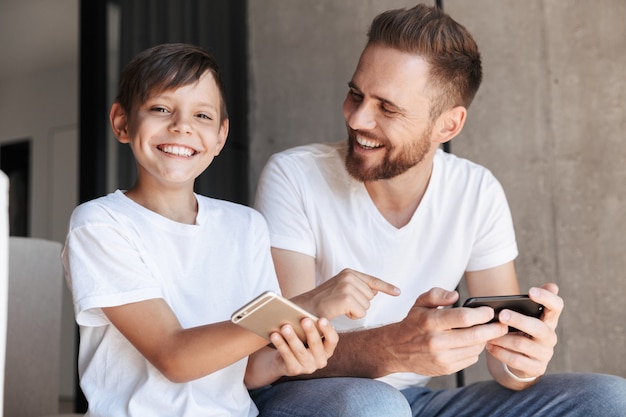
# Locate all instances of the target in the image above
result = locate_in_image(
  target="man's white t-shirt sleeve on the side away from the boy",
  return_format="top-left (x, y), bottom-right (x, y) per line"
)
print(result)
top-left (467, 173), bottom-right (518, 271)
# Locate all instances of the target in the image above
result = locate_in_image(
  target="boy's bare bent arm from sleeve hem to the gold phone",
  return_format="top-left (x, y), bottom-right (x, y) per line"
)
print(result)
top-left (102, 298), bottom-right (267, 382)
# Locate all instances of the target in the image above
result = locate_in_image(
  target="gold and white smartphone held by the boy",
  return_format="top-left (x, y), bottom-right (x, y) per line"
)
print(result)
top-left (231, 291), bottom-right (317, 341)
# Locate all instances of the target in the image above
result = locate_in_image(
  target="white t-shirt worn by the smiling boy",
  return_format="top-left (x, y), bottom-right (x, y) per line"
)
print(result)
top-left (63, 190), bottom-right (278, 417)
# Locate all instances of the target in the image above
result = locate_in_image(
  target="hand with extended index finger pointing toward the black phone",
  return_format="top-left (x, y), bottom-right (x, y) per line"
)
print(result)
top-left (292, 269), bottom-right (400, 319)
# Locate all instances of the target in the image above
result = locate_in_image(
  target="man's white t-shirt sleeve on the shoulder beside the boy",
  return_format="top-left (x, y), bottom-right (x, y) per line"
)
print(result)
top-left (254, 154), bottom-right (316, 257)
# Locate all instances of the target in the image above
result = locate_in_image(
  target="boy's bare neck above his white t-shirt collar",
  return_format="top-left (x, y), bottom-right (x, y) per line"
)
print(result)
top-left (126, 186), bottom-right (198, 224)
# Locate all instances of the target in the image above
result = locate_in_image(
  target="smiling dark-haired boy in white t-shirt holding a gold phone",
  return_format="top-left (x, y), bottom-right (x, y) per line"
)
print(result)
top-left (62, 44), bottom-right (394, 417)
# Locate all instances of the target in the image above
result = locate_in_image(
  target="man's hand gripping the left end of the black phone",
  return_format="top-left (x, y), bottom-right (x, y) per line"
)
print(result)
top-left (384, 288), bottom-right (508, 376)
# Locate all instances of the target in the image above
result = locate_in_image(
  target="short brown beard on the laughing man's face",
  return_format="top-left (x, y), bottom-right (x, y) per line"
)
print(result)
top-left (346, 126), bottom-right (432, 182)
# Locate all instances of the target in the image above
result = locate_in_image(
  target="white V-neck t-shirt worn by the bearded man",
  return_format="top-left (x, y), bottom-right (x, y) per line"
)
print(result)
top-left (255, 143), bottom-right (517, 389)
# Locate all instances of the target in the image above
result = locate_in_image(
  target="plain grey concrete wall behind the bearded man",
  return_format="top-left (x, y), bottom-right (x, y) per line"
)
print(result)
top-left (248, 0), bottom-right (626, 385)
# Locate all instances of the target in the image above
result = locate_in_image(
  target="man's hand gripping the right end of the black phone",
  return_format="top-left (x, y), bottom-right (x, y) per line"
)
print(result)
top-left (487, 284), bottom-right (564, 385)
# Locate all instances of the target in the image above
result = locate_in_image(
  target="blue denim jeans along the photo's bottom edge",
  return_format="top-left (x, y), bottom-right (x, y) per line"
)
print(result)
top-left (251, 373), bottom-right (626, 417)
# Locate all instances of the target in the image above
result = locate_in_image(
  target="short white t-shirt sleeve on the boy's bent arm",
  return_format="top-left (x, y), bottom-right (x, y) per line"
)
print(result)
top-left (63, 211), bottom-right (163, 326)
